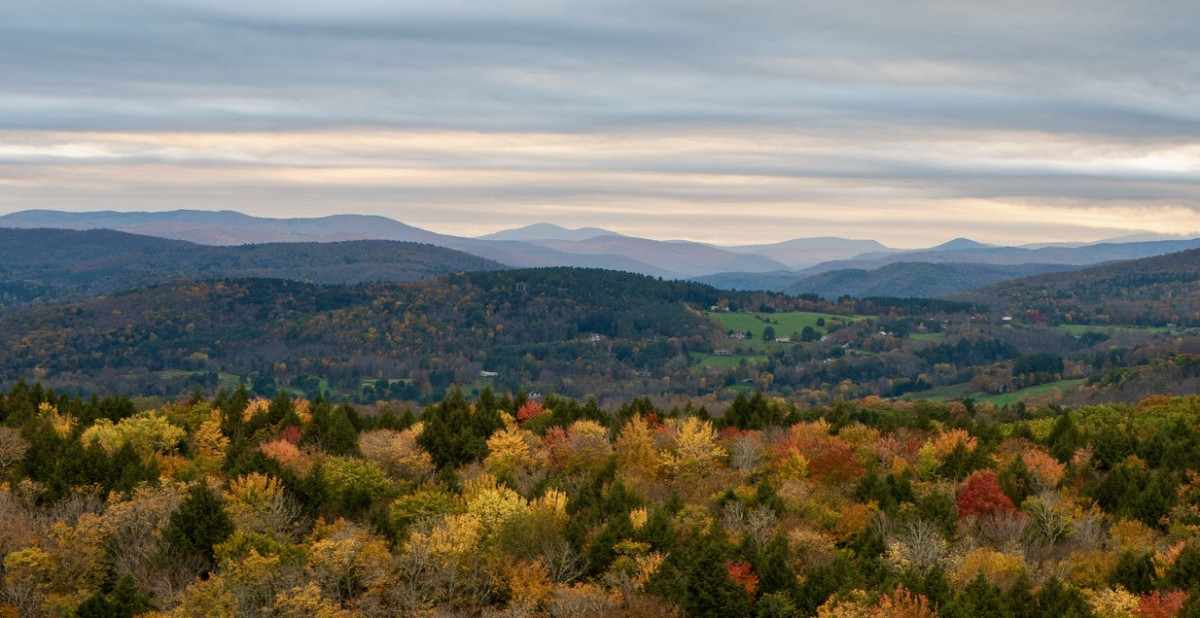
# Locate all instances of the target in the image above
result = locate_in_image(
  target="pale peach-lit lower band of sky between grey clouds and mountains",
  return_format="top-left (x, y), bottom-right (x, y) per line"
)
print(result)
top-left (0, 128), bottom-right (1200, 246)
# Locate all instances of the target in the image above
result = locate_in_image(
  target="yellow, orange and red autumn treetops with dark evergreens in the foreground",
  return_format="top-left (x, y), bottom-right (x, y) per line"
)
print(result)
top-left (0, 382), bottom-right (1200, 618)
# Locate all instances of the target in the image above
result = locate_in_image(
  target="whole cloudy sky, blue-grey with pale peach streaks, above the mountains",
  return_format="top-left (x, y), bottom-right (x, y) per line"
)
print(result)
top-left (0, 0), bottom-right (1200, 247)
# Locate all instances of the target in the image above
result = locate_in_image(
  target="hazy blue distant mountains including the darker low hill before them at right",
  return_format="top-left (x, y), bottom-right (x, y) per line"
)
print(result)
top-left (0, 210), bottom-right (1200, 298)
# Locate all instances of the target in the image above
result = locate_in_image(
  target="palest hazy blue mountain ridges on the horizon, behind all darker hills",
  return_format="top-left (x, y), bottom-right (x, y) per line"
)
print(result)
top-left (9, 210), bottom-right (1200, 289)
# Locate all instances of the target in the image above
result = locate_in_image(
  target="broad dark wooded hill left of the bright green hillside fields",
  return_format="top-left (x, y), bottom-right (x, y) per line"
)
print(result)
top-left (0, 269), bottom-right (787, 398)
